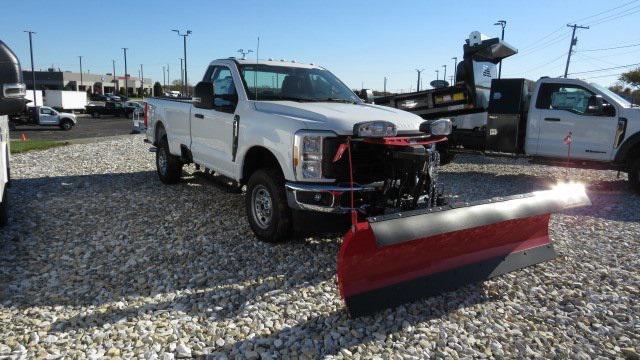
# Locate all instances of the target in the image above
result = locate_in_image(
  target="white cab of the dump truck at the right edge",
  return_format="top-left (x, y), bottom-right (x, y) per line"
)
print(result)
top-left (525, 78), bottom-right (640, 162)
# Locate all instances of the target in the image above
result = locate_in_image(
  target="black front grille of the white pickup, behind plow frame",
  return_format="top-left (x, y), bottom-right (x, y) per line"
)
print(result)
top-left (322, 137), bottom-right (385, 184)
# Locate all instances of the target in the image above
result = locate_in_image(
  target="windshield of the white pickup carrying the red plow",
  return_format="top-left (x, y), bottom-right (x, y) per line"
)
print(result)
top-left (240, 64), bottom-right (361, 103)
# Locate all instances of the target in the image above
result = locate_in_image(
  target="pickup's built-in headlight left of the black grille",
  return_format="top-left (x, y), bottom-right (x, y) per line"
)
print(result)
top-left (293, 131), bottom-right (335, 181)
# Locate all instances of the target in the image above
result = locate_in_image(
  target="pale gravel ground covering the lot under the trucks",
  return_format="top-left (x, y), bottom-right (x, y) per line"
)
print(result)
top-left (0, 136), bottom-right (640, 359)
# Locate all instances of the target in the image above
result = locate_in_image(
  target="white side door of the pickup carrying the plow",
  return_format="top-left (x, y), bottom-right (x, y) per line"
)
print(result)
top-left (191, 66), bottom-right (238, 177)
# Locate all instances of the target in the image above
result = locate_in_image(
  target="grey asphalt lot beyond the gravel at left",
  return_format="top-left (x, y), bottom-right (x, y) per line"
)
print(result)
top-left (10, 116), bottom-right (132, 141)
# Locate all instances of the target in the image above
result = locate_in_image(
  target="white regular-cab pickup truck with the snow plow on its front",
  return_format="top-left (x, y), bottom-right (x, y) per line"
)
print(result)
top-left (144, 58), bottom-right (451, 241)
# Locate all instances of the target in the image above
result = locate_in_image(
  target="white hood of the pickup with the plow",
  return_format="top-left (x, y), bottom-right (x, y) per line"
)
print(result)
top-left (255, 101), bottom-right (424, 135)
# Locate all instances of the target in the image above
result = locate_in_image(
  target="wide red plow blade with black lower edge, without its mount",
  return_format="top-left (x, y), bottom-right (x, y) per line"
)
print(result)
top-left (338, 185), bottom-right (591, 316)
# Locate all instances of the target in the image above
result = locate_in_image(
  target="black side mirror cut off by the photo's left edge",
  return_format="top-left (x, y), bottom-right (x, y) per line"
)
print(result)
top-left (0, 41), bottom-right (26, 115)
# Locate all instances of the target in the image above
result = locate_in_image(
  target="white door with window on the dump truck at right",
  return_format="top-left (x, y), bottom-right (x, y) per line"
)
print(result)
top-left (536, 83), bottom-right (617, 161)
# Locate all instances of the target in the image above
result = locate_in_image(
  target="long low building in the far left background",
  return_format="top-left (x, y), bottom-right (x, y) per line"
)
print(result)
top-left (22, 69), bottom-right (154, 96)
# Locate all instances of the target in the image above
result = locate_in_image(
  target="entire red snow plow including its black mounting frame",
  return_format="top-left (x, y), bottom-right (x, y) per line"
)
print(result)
top-left (333, 124), bottom-right (590, 316)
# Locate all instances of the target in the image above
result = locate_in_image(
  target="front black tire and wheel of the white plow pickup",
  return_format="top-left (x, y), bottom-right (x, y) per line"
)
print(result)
top-left (245, 169), bottom-right (293, 243)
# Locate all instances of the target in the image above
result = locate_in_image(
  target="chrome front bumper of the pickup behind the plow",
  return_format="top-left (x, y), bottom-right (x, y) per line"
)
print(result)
top-left (285, 182), bottom-right (382, 214)
